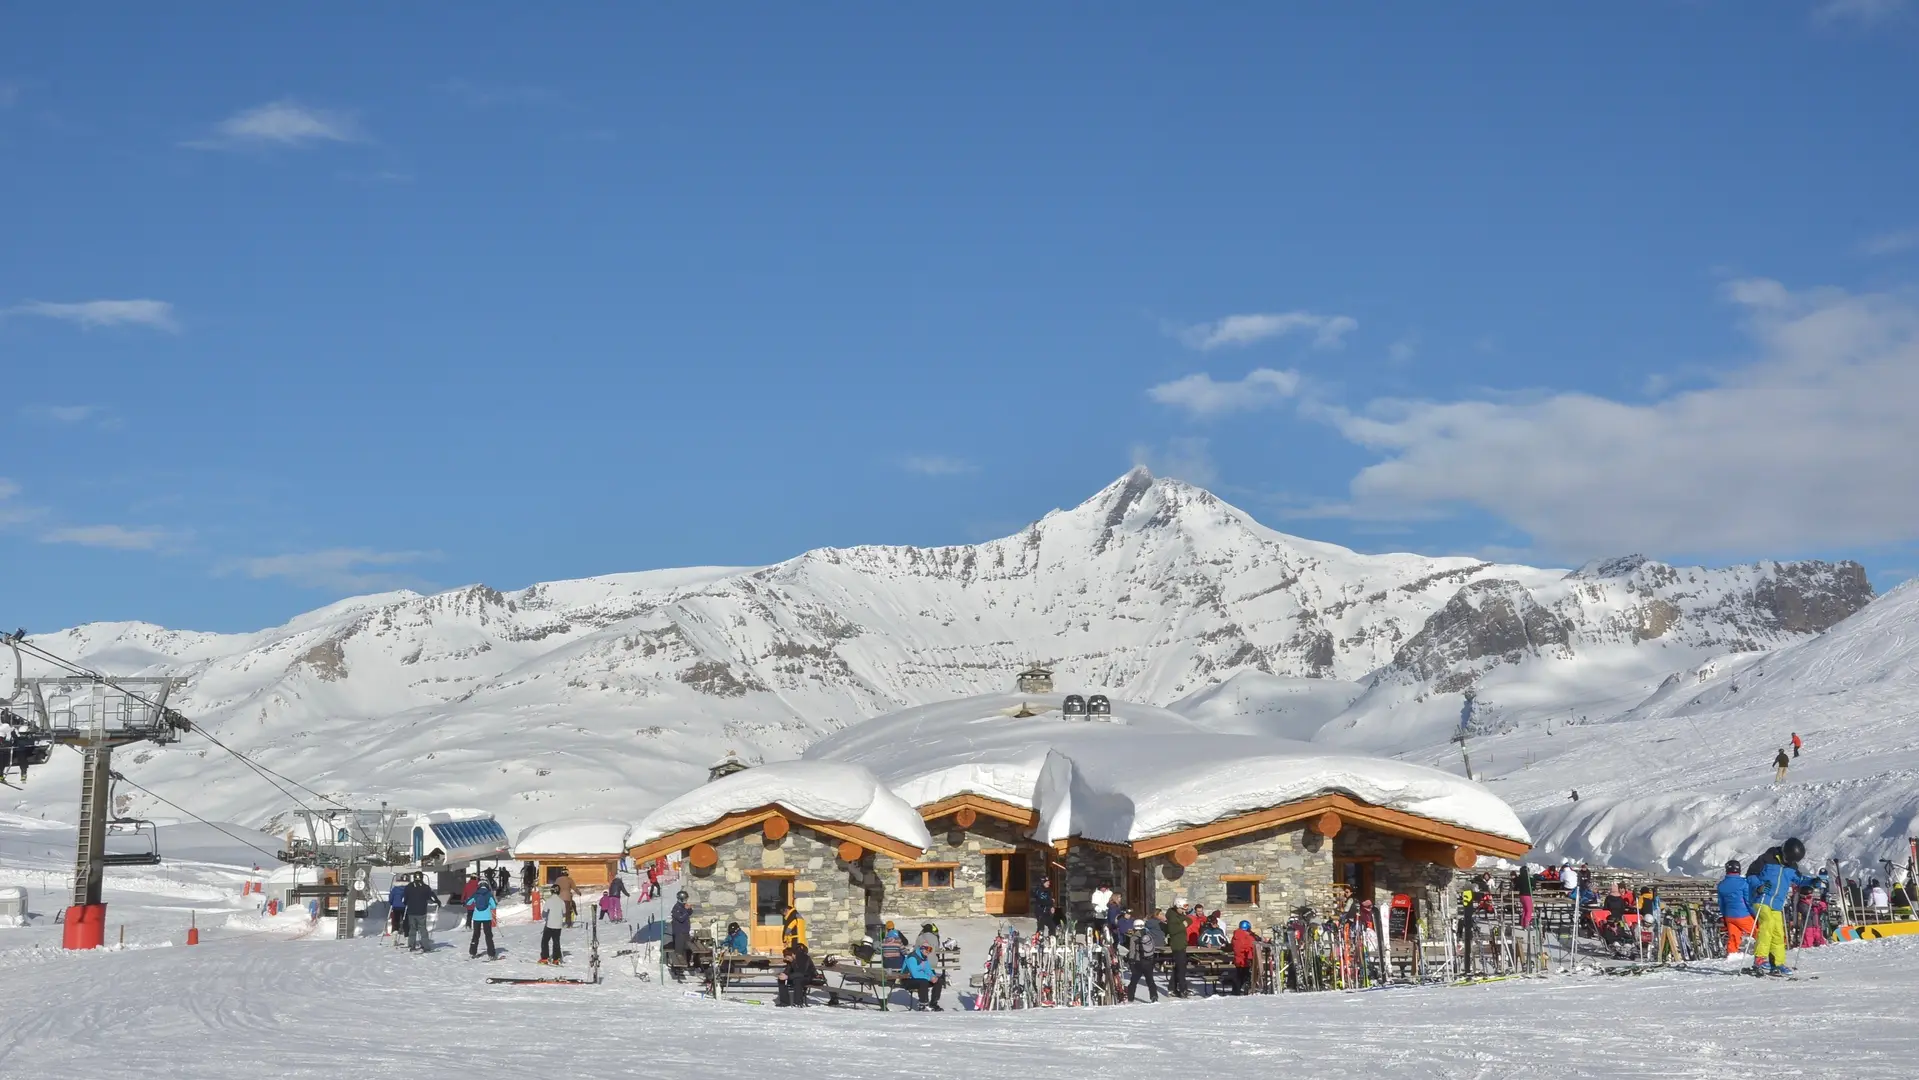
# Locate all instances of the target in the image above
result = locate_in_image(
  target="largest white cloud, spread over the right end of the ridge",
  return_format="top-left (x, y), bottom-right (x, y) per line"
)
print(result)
top-left (1311, 280), bottom-right (1919, 556)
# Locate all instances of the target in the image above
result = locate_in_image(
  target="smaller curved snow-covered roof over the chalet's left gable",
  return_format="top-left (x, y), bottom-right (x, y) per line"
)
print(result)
top-left (628, 762), bottom-right (933, 850)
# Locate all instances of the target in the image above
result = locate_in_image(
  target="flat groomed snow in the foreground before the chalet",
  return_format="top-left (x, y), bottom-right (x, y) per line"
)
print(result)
top-left (0, 819), bottom-right (1919, 1080)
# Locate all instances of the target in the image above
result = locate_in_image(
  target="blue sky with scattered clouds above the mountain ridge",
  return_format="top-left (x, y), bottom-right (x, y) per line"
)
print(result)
top-left (0, 0), bottom-right (1919, 629)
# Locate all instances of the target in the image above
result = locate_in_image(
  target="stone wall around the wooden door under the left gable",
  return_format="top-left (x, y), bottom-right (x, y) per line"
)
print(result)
top-left (679, 823), bottom-right (883, 953)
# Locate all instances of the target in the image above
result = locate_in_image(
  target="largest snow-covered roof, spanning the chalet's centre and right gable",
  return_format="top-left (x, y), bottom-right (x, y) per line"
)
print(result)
top-left (806, 694), bottom-right (1531, 844)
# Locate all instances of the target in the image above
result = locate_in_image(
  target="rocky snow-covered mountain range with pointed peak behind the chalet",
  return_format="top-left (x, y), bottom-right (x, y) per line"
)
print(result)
top-left (0, 470), bottom-right (1871, 855)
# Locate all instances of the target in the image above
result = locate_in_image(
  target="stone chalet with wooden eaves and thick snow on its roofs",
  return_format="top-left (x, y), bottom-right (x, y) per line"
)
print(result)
top-left (629, 693), bottom-right (1531, 951)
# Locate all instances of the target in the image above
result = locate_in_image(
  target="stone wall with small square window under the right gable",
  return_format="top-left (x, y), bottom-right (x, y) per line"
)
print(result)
top-left (1146, 825), bottom-right (1334, 930)
